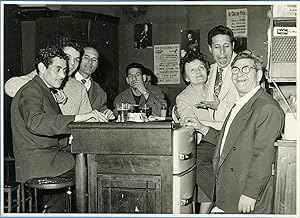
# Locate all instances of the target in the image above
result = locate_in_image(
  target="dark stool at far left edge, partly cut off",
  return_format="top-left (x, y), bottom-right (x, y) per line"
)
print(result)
top-left (4, 183), bottom-right (21, 213)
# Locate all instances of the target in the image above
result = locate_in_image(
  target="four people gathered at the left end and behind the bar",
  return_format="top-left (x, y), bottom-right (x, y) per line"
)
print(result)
top-left (4, 38), bottom-right (166, 211)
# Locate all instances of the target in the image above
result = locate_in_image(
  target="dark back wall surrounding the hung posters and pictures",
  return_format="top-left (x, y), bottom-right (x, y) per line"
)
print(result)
top-left (119, 5), bottom-right (269, 112)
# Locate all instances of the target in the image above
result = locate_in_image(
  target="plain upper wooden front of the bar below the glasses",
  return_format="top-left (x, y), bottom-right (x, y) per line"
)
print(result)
top-left (72, 123), bottom-right (172, 155)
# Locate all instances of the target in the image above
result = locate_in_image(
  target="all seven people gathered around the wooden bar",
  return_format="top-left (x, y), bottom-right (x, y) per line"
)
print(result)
top-left (5, 26), bottom-right (284, 213)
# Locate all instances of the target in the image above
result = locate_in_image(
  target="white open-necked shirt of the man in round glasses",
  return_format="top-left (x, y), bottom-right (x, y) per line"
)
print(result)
top-left (220, 86), bottom-right (260, 155)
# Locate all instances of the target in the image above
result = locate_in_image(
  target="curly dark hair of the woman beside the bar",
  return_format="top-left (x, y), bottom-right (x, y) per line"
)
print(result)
top-left (180, 50), bottom-right (210, 81)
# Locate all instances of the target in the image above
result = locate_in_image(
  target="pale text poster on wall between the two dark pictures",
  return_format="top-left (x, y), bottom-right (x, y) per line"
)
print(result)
top-left (154, 44), bottom-right (180, 84)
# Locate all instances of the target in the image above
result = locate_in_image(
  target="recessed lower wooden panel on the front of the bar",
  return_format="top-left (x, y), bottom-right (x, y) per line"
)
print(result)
top-left (98, 174), bottom-right (161, 213)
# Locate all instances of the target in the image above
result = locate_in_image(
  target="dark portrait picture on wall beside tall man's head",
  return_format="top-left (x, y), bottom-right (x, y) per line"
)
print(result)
top-left (180, 30), bottom-right (200, 57)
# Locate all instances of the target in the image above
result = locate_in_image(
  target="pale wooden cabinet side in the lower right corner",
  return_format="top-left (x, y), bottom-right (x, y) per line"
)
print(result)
top-left (274, 141), bottom-right (296, 214)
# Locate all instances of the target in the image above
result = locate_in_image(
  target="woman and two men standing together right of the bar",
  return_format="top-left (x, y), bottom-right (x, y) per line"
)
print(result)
top-left (173, 26), bottom-right (284, 214)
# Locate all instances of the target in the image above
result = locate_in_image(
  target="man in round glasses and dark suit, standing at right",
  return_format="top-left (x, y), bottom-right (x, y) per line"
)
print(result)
top-left (186, 51), bottom-right (284, 214)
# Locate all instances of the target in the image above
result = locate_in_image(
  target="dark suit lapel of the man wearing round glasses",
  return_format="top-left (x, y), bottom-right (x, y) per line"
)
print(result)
top-left (218, 88), bottom-right (264, 168)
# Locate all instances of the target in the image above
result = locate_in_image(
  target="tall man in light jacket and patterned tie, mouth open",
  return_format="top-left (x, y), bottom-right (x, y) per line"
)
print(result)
top-left (199, 26), bottom-right (238, 128)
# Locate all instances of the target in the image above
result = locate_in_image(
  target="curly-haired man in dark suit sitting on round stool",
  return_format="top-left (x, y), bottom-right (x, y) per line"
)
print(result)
top-left (11, 46), bottom-right (104, 182)
